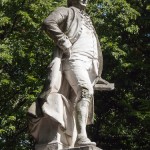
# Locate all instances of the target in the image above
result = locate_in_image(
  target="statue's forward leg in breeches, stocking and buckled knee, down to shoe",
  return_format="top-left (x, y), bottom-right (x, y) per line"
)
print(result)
top-left (64, 61), bottom-right (96, 146)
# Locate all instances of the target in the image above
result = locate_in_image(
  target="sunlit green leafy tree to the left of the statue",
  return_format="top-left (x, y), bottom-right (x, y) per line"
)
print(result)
top-left (0, 0), bottom-right (63, 150)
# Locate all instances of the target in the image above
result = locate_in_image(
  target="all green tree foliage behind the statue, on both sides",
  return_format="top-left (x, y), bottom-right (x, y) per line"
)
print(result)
top-left (0, 0), bottom-right (150, 150)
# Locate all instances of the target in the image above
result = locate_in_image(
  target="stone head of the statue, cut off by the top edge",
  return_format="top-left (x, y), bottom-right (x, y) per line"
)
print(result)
top-left (67, 0), bottom-right (88, 9)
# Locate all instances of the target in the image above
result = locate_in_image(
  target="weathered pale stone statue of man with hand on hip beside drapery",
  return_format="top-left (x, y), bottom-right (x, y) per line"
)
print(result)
top-left (28, 0), bottom-right (113, 150)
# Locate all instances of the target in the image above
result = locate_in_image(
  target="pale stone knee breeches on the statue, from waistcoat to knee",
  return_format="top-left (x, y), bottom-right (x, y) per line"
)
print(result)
top-left (63, 59), bottom-right (99, 102)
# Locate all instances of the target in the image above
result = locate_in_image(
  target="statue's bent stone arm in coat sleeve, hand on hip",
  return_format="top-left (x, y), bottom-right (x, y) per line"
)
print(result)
top-left (43, 7), bottom-right (72, 52)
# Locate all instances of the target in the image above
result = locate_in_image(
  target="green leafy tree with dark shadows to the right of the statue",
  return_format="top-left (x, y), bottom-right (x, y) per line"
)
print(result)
top-left (87, 0), bottom-right (150, 149)
